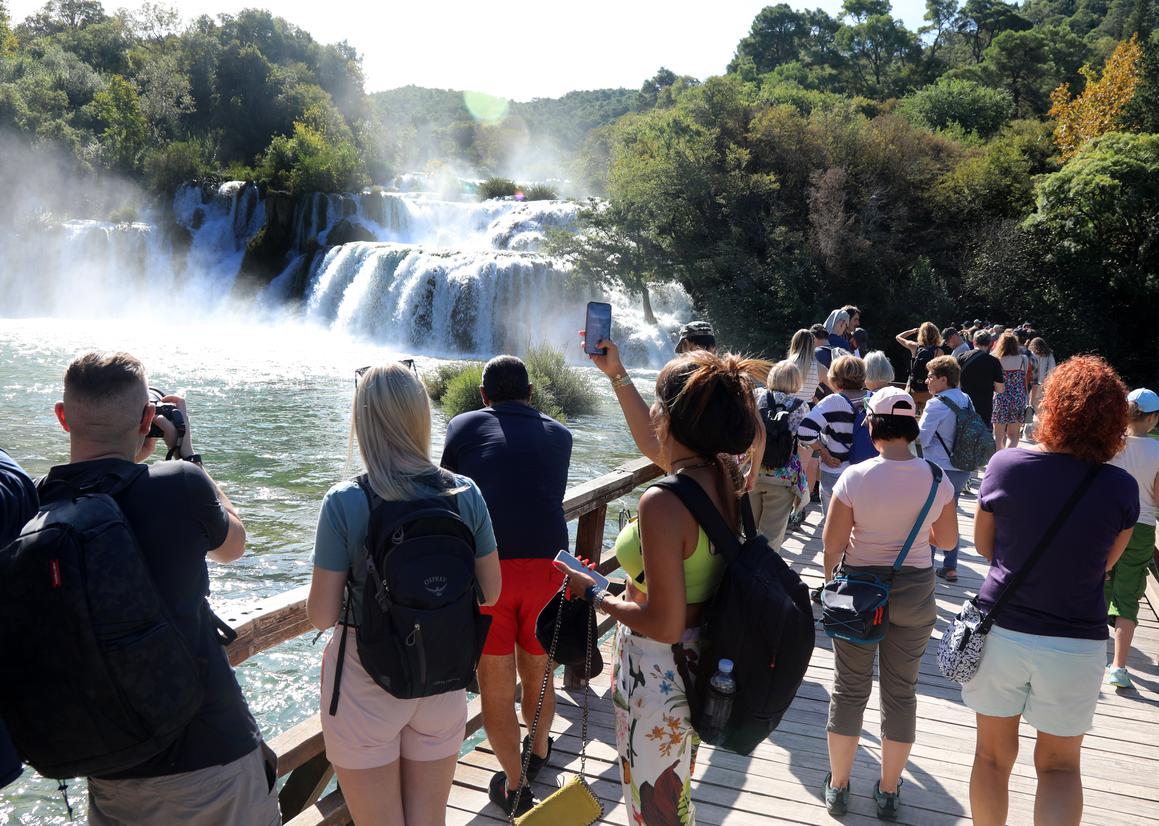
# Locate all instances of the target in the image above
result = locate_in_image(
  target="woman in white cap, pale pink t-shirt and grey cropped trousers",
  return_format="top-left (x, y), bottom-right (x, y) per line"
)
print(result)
top-left (823, 387), bottom-right (957, 820)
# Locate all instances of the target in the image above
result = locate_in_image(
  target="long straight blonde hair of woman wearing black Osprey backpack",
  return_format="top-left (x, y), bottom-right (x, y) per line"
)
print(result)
top-left (350, 364), bottom-right (455, 502)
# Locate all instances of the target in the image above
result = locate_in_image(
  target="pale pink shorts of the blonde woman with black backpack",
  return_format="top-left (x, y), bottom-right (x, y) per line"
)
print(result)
top-left (322, 626), bottom-right (467, 769)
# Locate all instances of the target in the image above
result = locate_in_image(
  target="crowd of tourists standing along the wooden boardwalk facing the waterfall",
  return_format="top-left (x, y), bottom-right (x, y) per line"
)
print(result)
top-left (0, 306), bottom-right (1159, 826)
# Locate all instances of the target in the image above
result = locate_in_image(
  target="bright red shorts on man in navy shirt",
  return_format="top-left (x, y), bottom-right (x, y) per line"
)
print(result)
top-left (482, 560), bottom-right (563, 657)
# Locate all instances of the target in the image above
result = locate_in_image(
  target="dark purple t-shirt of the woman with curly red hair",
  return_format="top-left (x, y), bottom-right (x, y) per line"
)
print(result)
top-left (978, 447), bottom-right (1139, 639)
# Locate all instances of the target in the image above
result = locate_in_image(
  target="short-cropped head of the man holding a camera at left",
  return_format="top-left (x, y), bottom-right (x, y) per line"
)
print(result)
top-left (57, 352), bottom-right (152, 455)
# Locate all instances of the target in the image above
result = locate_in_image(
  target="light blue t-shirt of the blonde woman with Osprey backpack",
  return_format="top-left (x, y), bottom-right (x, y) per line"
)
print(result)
top-left (314, 474), bottom-right (496, 624)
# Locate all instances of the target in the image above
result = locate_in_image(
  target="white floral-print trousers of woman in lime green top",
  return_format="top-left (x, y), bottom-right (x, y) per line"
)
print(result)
top-left (612, 624), bottom-right (700, 826)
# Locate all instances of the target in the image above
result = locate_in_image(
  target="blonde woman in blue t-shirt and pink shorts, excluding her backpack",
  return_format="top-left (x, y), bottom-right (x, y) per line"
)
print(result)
top-left (306, 364), bottom-right (501, 826)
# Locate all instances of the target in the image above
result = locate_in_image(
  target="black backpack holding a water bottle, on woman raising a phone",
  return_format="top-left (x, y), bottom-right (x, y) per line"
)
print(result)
top-left (656, 475), bottom-right (816, 754)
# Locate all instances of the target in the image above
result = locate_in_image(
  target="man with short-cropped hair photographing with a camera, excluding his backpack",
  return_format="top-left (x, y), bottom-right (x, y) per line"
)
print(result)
top-left (41, 352), bottom-right (282, 826)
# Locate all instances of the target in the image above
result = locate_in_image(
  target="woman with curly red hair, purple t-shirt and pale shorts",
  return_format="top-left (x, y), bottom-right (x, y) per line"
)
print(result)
top-left (962, 356), bottom-right (1139, 826)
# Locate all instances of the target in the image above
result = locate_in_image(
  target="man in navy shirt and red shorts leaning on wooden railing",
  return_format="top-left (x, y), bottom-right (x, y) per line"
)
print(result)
top-left (442, 356), bottom-right (571, 812)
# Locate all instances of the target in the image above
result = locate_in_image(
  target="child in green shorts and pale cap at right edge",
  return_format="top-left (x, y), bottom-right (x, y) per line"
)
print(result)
top-left (1105, 388), bottom-right (1159, 688)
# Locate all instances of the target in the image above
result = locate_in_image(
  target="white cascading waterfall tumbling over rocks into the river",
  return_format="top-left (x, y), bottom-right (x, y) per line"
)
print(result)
top-left (0, 181), bottom-right (688, 364)
